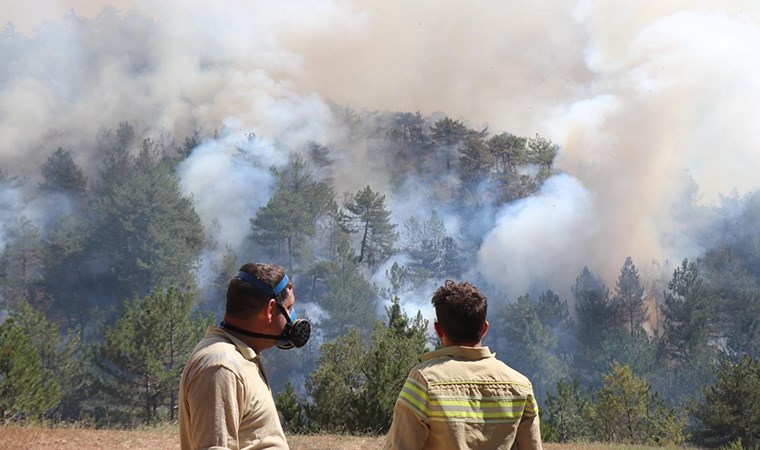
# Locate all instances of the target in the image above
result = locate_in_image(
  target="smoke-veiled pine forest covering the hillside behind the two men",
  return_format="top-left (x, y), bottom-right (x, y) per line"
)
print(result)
top-left (0, 110), bottom-right (760, 444)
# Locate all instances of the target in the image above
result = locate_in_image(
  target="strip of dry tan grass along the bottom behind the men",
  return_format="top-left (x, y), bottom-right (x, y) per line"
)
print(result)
top-left (0, 426), bottom-right (700, 450)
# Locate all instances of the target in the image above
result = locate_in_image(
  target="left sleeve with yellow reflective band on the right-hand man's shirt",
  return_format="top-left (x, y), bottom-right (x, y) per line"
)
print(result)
top-left (385, 371), bottom-right (430, 450)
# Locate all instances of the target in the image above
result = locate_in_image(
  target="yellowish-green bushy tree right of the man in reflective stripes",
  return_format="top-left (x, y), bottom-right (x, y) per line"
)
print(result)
top-left (586, 365), bottom-right (683, 445)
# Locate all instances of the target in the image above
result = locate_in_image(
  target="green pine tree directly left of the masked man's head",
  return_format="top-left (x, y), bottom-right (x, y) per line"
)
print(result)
top-left (97, 287), bottom-right (211, 423)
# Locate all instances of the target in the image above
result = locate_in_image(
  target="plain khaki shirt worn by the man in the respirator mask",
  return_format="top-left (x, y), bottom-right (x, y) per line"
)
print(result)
top-left (179, 327), bottom-right (288, 450)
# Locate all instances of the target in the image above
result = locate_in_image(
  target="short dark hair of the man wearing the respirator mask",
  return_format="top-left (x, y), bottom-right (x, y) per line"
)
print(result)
top-left (225, 263), bottom-right (293, 318)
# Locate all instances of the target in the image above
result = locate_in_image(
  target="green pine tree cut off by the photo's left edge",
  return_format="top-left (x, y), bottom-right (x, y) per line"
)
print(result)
top-left (0, 317), bottom-right (60, 423)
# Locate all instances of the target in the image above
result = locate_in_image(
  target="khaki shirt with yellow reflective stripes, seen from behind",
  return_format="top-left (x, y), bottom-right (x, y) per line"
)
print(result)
top-left (385, 346), bottom-right (541, 450)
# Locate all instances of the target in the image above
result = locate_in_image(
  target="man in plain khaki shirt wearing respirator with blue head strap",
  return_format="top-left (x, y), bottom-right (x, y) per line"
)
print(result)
top-left (179, 263), bottom-right (311, 450)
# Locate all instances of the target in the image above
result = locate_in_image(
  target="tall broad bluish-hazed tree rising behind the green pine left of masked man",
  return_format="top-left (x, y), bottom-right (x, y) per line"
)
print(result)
top-left (95, 134), bottom-right (203, 299)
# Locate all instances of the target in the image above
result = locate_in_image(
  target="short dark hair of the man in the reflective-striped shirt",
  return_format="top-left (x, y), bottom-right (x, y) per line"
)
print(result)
top-left (432, 280), bottom-right (488, 343)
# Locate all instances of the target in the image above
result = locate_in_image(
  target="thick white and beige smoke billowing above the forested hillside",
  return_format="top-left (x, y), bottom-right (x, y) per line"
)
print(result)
top-left (0, 0), bottom-right (760, 302)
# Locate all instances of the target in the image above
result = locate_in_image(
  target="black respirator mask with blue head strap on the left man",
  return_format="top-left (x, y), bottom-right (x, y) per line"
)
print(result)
top-left (219, 272), bottom-right (311, 350)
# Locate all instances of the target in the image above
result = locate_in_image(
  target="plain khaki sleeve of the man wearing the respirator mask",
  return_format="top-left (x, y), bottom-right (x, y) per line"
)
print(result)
top-left (187, 366), bottom-right (245, 450)
